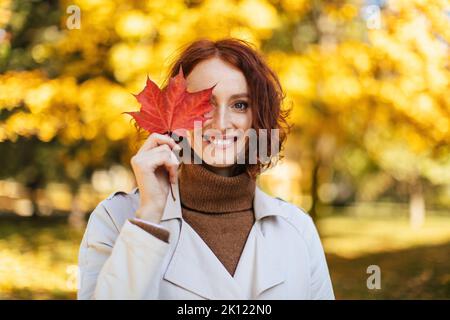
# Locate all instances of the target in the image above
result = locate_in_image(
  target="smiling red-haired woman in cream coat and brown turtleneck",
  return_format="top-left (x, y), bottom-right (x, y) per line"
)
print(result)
top-left (78, 39), bottom-right (334, 299)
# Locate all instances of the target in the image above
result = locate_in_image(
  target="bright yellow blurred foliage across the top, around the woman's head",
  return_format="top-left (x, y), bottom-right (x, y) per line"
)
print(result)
top-left (0, 0), bottom-right (450, 185)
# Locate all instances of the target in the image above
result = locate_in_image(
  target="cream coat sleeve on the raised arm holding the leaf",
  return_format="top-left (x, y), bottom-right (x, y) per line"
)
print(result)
top-left (78, 203), bottom-right (169, 299)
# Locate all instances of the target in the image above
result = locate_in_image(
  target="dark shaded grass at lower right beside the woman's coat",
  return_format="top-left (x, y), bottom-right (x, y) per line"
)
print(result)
top-left (327, 243), bottom-right (450, 299)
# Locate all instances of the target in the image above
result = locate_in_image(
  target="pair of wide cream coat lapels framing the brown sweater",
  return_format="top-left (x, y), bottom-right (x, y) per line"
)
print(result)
top-left (162, 184), bottom-right (285, 300)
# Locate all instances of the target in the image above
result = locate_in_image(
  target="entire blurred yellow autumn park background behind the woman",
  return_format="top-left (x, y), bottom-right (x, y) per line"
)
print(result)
top-left (0, 0), bottom-right (450, 299)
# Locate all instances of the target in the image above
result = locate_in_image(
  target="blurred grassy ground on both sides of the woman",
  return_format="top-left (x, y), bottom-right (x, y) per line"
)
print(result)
top-left (0, 210), bottom-right (450, 299)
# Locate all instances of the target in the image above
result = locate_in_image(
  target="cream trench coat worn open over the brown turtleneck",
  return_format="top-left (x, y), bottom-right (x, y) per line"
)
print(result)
top-left (78, 184), bottom-right (334, 300)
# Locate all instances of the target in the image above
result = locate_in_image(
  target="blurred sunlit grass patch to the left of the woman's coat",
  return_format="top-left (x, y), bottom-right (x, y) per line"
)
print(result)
top-left (0, 218), bottom-right (82, 299)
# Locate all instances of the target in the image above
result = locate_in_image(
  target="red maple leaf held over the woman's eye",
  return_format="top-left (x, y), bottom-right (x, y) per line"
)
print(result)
top-left (125, 67), bottom-right (215, 137)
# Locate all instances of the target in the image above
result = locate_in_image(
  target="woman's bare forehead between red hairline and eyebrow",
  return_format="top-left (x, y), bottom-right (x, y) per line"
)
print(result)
top-left (186, 58), bottom-right (247, 97)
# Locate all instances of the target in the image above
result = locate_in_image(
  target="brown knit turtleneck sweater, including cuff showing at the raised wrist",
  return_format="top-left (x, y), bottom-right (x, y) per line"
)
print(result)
top-left (134, 163), bottom-right (256, 276)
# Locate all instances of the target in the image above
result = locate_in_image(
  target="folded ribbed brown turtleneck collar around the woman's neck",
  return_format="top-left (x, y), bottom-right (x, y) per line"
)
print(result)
top-left (179, 163), bottom-right (256, 213)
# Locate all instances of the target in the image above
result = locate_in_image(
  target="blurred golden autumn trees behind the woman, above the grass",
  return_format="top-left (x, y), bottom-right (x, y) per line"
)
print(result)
top-left (0, 0), bottom-right (450, 224)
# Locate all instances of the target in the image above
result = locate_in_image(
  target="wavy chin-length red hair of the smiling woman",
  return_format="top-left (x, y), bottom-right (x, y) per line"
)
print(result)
top-left (166, 38), bottom-right (290, 177)
